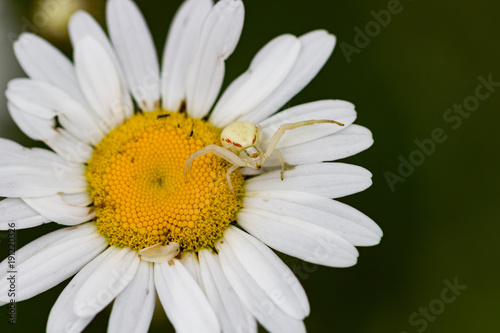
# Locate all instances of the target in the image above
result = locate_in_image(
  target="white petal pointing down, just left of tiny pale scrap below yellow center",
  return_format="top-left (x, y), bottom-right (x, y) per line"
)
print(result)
top-left (108, 261), bottom-right (156, 333)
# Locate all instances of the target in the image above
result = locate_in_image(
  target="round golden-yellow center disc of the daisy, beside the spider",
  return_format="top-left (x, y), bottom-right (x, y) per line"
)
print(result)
top-left (86, 111), bottom-right (243, 251)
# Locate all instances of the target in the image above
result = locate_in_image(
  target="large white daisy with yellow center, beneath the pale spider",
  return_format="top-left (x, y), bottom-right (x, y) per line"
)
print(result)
top-left (0, 0), bottom-right (382, 332)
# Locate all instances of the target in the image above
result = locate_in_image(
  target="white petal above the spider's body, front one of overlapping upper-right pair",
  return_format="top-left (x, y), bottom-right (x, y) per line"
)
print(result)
top-left (209, 35), bottom-right (301, 128)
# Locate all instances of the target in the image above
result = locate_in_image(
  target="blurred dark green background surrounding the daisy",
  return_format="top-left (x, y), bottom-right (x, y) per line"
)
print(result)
top-left (0, 0), bottom-right (500, 333)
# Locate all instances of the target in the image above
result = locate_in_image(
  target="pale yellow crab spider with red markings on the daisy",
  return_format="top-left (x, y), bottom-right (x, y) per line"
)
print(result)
top-left (184, 120), bottom-right (344, 193)
